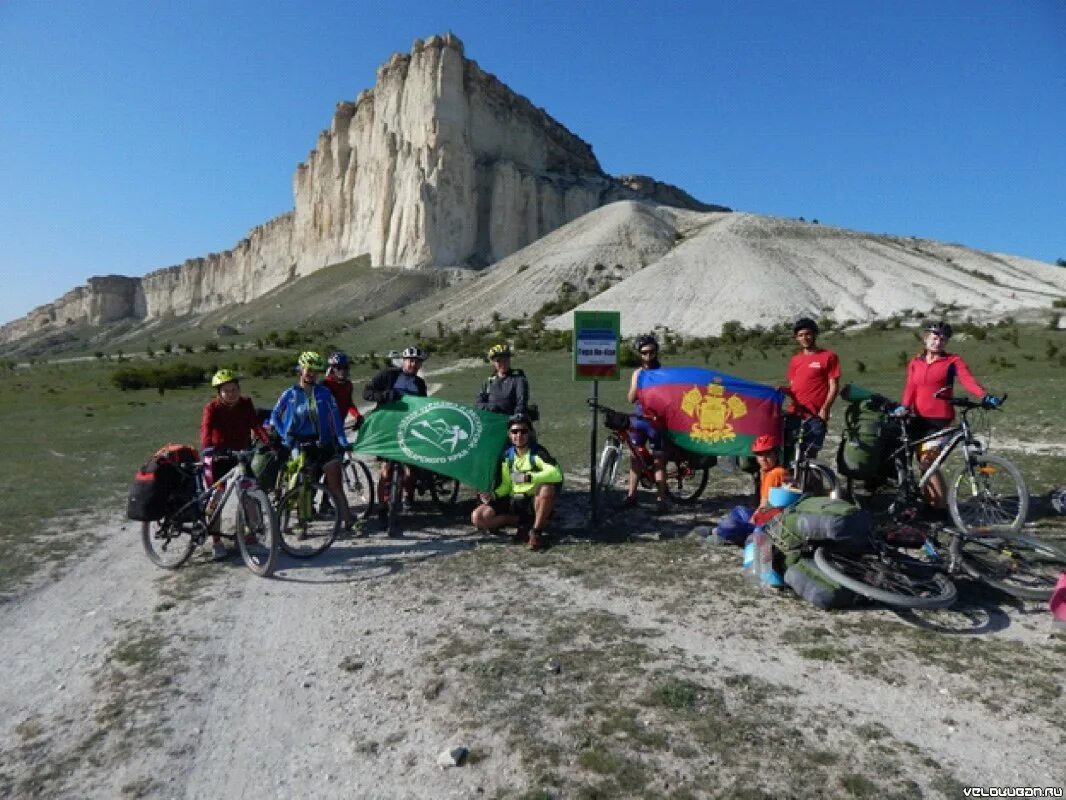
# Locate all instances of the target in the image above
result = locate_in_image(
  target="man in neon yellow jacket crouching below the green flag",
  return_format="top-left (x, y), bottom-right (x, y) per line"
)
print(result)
top-left (470, 415), bottom-right (563, 550)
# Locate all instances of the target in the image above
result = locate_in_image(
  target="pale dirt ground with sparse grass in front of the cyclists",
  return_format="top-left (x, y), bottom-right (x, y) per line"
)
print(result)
top-left (0, 498), bottom-right (1066, 798)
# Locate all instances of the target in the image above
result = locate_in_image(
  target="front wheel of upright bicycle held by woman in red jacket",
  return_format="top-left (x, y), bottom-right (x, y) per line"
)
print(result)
top-left (948, 453), bottom-right (1029, 533)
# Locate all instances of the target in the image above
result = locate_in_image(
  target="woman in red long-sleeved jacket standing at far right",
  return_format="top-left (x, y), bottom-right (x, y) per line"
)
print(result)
top-left (899, 322), bottom-right (1003, 508)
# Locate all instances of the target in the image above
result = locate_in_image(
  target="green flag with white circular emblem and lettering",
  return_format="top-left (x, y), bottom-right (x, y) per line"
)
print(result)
top-left (355, 395), bottom-right (507, 492)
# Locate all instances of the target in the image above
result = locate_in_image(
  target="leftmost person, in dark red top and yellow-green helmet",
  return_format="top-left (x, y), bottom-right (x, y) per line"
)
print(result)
top-left (200, 369), bottom-right (268, 561)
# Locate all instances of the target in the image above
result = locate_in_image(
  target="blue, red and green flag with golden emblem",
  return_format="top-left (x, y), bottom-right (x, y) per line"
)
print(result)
top-left (636, 367), bottom-right (785, 455)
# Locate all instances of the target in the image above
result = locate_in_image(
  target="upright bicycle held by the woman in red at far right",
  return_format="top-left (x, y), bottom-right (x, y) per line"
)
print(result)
top-left (847, 395), bottom-right (1029, 533)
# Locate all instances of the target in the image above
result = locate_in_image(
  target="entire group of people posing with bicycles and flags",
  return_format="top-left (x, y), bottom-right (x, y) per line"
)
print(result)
top-left (200, 317), bottom-right (1001, 559)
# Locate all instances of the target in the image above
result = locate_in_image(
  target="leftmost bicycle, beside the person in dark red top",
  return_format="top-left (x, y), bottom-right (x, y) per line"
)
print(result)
top-left (141, 450), bottom-right (281, 577)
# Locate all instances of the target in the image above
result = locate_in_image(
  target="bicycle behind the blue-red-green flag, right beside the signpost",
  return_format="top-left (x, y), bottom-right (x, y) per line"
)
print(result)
top-left (588, 399), bottom-right (710, 506)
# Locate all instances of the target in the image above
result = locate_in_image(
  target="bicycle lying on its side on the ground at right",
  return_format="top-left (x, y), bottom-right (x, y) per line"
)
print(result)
top-left (814, 526), bottom-right (1066, 608)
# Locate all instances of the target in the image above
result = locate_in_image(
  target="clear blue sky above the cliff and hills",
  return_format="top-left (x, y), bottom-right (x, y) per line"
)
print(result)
top-left (0, 0), bottom-right (1066, 321)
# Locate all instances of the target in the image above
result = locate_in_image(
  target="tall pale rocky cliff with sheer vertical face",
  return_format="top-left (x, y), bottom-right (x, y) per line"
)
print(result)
top-left (0, 34), bottom-right (727, 343)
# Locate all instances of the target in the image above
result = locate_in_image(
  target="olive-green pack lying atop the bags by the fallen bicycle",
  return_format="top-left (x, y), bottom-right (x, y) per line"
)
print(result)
top-left (766, 497), bottom-right (872, 566)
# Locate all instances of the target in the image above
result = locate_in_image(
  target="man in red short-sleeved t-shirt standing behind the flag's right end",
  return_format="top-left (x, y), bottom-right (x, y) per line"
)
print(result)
top-left (788, 317), bottom-right (840, 458)
